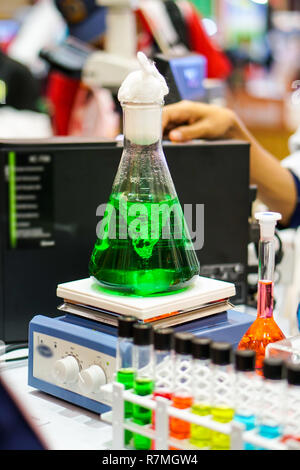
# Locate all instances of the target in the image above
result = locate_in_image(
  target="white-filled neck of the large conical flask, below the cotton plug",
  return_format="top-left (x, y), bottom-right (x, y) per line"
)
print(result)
top-left (122, 103), bottom-right (162, 147)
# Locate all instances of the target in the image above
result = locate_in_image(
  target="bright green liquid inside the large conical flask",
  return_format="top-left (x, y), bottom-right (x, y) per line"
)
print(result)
top-left (89, 193), bottom-right (199, 296)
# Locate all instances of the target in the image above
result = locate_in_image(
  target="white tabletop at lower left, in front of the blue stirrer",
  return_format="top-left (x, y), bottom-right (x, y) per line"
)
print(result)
top-left (1, 360), bottom-right (112, 450)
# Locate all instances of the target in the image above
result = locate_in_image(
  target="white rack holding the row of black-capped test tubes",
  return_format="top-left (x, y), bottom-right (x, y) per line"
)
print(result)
top-left (101, 382), bottom-right (299, 451)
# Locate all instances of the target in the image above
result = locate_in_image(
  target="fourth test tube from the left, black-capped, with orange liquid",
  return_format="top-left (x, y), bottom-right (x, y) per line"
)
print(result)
top-left (170, 333), bottom-right (193, 449)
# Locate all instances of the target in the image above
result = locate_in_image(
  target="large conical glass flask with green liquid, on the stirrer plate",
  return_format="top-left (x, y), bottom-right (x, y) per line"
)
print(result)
top-left (89, 103), bottom-right (199, 296)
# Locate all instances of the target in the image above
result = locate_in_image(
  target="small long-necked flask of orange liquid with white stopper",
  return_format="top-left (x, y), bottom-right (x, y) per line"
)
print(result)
top-left (238, 212), bottom-right (285, 375)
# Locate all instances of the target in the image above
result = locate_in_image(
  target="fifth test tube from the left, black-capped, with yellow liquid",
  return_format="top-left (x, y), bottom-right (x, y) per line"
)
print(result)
top-left (190, 337), bottom-right (212, 448)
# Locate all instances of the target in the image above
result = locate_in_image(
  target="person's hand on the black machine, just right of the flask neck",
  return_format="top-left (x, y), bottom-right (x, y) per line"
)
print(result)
top-left (162, 101), bottom-right (245, 142)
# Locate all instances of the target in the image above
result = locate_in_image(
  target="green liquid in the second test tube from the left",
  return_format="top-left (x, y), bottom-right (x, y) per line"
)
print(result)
top-left (133, 377), bottom-right (154, 450)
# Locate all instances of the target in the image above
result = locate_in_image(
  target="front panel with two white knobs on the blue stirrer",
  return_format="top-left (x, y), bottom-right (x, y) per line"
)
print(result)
top-left (29, 315), bottom-right (117, 413)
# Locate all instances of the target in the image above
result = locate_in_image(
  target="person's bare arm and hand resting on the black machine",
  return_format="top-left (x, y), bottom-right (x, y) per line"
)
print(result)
top-left (162, 101), bottom-right (298, 225)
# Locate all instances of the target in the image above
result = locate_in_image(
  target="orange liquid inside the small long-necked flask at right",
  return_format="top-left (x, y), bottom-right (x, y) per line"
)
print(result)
top-left (238, 280), bottom-right (285, 375)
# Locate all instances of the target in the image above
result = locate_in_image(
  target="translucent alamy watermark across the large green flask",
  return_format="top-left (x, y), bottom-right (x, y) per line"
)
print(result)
top-left (96, 199), bottom-right (204, 250)
